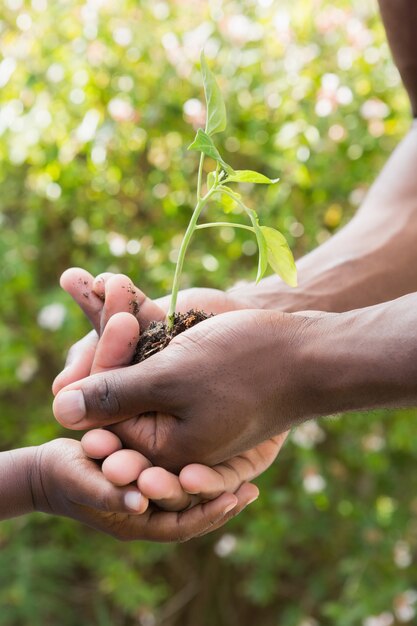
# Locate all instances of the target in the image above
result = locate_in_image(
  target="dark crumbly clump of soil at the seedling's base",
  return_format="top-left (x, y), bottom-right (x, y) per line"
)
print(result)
top-left (131, 309), bottom-right (213, 365)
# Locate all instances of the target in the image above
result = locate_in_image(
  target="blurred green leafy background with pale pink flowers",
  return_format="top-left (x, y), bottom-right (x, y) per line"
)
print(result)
top-left (0, 0), bottom-right (417, 626)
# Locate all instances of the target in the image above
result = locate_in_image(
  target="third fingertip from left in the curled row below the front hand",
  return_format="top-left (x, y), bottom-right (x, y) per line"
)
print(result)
top-left (138, 467), bottom-right (191, 511)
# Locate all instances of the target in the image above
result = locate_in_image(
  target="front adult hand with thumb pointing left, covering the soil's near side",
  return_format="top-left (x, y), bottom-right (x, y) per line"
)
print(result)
top-left (54, 310), bottom-right (314, 470)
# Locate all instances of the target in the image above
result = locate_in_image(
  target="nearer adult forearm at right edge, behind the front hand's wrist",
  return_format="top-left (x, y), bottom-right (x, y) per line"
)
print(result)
top-left (296, 293), bottom-right (417, 418)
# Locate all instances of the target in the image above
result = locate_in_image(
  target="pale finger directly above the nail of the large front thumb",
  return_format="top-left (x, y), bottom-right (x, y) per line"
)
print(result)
top-left (52, 330), bottom-right (98, 395)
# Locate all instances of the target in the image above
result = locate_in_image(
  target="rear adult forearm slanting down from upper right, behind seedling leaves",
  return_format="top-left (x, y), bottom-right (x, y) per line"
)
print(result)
top-left (232, 125), bottom-right (417, 312)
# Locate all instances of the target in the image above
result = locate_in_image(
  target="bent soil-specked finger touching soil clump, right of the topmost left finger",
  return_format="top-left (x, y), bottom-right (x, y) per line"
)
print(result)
top-left (99, 274), bottom-right (165, 329)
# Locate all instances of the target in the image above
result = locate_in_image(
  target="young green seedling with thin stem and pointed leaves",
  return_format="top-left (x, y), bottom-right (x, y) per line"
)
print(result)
top-left (167, 52), bottom-right (297, 331)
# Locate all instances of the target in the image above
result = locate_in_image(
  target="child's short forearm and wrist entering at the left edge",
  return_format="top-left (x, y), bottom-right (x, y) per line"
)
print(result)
top-left (0, 447), bottom-right (37, 519)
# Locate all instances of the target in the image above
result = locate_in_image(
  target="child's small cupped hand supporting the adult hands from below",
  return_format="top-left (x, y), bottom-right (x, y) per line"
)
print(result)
top-left (32, 439), bottom-right (258, 542)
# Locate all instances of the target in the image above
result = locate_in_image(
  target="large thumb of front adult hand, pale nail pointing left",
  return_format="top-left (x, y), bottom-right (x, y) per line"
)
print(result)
top-left (53, 347), bottom-right (181, 430)
